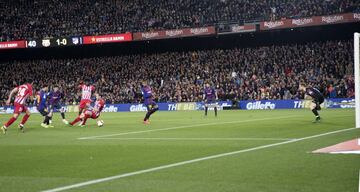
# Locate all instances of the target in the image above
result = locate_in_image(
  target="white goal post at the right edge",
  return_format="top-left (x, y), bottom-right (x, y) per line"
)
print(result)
top-left (354, 33), bottom-right (360, 128)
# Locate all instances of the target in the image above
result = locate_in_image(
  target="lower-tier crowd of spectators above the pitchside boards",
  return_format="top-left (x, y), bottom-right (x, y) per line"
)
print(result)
top-left (0, 38), bottom-right (354, 106)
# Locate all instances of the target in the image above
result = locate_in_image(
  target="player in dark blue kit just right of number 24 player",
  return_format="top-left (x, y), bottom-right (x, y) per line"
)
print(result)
top-left (36, 85), bottom-right (52, 128)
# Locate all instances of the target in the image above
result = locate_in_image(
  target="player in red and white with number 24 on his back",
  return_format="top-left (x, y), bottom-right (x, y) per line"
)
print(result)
top-left (1, 80), bottom-right (33, 134)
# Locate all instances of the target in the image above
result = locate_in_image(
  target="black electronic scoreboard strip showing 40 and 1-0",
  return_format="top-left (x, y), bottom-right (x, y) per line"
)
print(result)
top-left (26, 37), bottom-right (83, 48)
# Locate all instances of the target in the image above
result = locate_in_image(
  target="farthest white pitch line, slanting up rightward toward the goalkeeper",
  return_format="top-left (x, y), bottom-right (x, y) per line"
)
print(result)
top-left (78, 115), bottom-right (299, 140)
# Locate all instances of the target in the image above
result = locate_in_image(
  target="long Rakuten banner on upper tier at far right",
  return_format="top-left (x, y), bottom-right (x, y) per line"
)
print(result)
top-left (260, 13), bottom-right (360, 30)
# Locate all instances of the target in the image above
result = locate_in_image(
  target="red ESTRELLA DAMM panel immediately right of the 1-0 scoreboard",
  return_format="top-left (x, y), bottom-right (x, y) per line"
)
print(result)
top-left (83, 33), bottom-right (132, 44)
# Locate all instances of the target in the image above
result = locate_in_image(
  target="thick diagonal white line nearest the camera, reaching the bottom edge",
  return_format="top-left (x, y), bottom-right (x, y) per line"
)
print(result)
top-left (42, 127), bottom-right (357, 192)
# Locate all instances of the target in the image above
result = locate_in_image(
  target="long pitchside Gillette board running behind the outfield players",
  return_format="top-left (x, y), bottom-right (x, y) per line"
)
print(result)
top-left (0, 101), bottom-right (232, 114)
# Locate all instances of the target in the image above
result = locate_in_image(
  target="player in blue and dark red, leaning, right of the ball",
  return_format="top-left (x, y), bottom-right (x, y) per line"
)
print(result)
top-left (141, 81), bottom-right (159, 124)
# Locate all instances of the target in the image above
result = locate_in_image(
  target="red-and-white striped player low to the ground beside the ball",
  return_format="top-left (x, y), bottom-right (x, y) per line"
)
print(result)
top-left (70, 93), bottom-right (105, 126)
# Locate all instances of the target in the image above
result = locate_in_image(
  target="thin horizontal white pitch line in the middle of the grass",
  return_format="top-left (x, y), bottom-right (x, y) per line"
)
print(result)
top-left (88, 137), bottom-right (295, 141)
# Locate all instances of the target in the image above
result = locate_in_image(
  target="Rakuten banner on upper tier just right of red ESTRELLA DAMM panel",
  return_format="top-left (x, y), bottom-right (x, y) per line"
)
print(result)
top-left (134, 26), bottom-right (215, 40)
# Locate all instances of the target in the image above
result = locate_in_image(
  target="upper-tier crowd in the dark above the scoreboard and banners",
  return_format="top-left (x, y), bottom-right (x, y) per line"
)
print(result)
top-left (0, 0), bottom-right (360, 41)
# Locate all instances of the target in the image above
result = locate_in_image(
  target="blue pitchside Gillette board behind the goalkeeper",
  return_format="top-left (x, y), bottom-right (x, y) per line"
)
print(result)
top-left (239, 98), bottom-right (355, 110)
